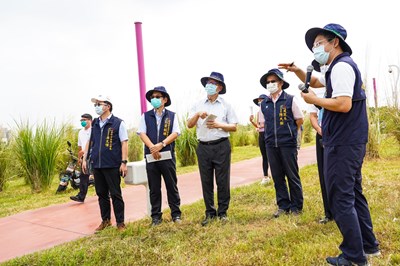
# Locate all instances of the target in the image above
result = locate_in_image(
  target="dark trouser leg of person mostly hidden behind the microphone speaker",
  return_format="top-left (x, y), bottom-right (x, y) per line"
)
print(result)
top-left (315, 133), bottom-right (333, 219)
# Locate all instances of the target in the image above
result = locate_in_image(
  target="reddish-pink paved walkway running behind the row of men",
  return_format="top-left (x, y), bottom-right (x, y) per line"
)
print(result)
top-left (0, 146), bottom-right (316, 263)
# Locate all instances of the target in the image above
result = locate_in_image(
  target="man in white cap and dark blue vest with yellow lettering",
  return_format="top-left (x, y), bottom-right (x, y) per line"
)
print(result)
top-left (82, 95), bottom-right (128, 231)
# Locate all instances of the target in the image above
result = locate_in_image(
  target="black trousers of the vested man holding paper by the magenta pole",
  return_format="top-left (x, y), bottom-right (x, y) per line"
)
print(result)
top-left (146, 160), bottom-right (181, 219)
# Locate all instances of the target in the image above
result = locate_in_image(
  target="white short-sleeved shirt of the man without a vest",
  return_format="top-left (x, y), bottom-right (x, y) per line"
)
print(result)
top-left (188, 96), bottom-right (238, 141)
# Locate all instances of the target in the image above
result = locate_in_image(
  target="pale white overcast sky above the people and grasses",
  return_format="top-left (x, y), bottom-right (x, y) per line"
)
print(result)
top-left (0, 0), bottom-right (400, 127)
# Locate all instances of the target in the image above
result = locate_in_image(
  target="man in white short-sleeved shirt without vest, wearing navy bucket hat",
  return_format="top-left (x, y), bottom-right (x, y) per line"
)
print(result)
top-left (187, 72), bottom-right (238, 226)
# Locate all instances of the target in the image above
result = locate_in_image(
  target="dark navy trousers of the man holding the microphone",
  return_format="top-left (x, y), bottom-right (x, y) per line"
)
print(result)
top-left (324, 144), bottom-right (379, 263)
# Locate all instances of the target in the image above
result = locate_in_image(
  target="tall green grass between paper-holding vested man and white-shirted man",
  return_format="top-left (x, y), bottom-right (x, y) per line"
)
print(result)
top-left (175, 116), bottom-right (197, 166)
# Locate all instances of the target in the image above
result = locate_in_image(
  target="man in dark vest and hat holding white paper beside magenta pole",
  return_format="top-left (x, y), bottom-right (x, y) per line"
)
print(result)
top-left (137, 86), bottom-right (181, 226)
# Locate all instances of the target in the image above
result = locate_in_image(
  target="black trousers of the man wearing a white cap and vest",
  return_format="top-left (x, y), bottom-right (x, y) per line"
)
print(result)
top-left (94, 168), bottom-right (125, 223)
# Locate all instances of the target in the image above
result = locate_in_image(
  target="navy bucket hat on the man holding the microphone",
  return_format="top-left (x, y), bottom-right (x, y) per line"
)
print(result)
top-left (305, 23), bottom-right (353, 55)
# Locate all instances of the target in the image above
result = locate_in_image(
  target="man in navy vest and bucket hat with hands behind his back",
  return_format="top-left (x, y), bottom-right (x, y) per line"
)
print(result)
top-left (260, 68), bottom-right (304, 218)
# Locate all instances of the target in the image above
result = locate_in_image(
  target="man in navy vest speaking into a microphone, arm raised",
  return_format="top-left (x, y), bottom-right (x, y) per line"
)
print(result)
top-left (280, 24), bottom-right (380, 265)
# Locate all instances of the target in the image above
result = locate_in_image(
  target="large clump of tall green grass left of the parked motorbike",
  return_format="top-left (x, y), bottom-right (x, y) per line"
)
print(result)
top-left (13, 121), bottom-right (64, 192)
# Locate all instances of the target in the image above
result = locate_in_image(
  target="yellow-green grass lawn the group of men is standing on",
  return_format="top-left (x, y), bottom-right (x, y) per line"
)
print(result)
top-left (0, 139), bottom-right (400, 265)
